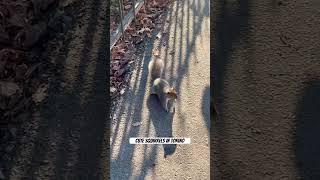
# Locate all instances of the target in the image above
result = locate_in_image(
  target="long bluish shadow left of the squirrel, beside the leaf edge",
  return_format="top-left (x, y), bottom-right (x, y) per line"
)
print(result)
top-left (110, 21), bottom-right (156, 179)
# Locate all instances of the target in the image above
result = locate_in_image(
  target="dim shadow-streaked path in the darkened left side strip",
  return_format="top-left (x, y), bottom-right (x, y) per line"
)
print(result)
top-left (5, 0), bottom-right (109, 179)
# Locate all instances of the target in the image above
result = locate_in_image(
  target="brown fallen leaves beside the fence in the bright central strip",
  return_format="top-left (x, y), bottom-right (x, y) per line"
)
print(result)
top-left (110, 0), bottom-right (170, 98)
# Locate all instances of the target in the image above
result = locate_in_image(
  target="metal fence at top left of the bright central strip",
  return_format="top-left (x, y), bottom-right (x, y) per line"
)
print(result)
top-left (110, 0), bottom-right (146, 50)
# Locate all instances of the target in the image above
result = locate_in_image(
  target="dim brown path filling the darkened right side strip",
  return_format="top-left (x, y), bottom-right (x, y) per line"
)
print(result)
top-left (211, 0), bottom-right (320, 179)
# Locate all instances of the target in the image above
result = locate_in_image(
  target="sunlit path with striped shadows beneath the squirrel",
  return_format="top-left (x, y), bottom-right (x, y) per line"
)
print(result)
top-left (110, 0), bottom-right (210, 179)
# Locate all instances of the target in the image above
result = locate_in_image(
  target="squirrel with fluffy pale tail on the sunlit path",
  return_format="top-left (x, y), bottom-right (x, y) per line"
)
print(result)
top-left (149, 58), bottom-right (178, 112)
